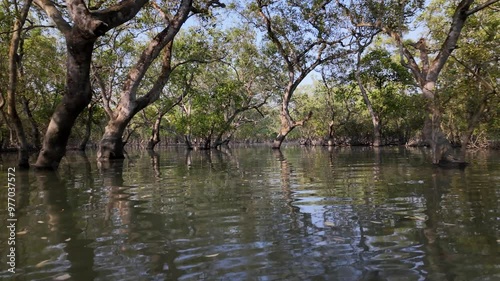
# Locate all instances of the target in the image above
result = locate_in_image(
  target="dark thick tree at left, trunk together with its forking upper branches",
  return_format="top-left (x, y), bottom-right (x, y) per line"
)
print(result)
top-left (33, 0), bottom-right (148, 169)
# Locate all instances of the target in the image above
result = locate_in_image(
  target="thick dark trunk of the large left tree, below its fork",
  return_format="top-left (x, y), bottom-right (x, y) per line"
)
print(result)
top-left (36, 36), bottom-right (95, 169)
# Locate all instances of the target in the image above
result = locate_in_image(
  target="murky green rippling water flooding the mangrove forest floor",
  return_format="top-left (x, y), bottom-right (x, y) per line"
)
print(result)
top-left (0, 147), bottom-right (500, 280)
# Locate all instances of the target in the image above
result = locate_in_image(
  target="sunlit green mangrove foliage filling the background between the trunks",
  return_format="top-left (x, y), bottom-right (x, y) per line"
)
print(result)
top-left (0, 0), bottom-right (500, 149)
